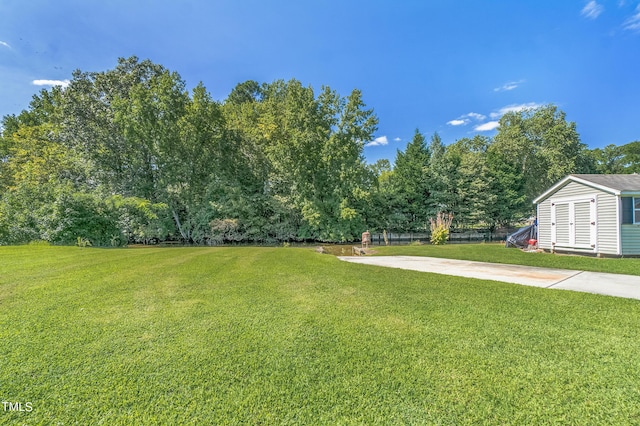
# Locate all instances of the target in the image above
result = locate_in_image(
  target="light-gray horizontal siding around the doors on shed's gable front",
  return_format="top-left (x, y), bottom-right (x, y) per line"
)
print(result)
top-left (538, 181), bottom-right (618, 255)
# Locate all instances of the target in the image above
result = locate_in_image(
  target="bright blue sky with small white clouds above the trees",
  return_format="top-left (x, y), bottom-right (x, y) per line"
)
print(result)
top-left (0, 0), bottom-right (640, 162)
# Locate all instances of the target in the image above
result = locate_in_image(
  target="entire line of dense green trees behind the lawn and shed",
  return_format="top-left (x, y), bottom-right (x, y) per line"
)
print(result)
top-left (0, 57), bottom-right (640, 246)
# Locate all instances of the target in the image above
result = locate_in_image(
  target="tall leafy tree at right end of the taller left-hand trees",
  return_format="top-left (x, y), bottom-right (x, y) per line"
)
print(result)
top-left (224, 80), bottom-right (377, 241)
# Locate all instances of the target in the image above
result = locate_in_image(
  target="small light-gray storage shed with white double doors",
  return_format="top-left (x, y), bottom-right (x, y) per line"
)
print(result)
top-left (533, 174), bottom-right (640, 256)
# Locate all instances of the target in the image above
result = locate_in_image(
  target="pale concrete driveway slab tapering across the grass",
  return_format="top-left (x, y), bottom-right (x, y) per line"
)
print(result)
top-left (338, 256), bottom-right (640, 300)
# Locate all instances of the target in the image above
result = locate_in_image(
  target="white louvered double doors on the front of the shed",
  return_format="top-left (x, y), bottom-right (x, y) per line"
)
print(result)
top-left (551, 197), bottom-right (597, 250)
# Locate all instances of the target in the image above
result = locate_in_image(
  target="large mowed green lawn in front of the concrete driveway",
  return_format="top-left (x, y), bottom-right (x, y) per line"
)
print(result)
top-left (0, 246), bottom-right (640, 425)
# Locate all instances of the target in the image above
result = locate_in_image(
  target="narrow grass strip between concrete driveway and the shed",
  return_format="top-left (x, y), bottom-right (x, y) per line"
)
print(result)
top-left (372, 243), bottom-right (640, 275)
